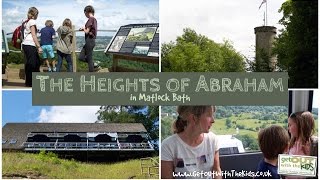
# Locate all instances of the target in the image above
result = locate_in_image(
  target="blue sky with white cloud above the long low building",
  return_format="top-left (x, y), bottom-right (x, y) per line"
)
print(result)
top-left (2, 90), bottom-right (100, 126)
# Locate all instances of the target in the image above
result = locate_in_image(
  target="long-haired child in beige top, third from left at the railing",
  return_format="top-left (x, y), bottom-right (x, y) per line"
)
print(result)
top-left (57, 18), bottom-right (73, 72)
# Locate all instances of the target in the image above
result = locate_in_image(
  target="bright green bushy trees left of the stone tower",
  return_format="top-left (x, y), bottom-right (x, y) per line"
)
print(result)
top-left (161, 28), bottom-right (245, 72)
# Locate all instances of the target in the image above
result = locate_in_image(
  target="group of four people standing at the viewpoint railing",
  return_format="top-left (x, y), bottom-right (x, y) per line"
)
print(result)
top-left (22, 5), bottom-right (97, 87)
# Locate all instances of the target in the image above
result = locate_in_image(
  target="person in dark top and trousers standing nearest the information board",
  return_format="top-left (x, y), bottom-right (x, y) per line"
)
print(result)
top-left (79, 6), bottom-right (97, 72)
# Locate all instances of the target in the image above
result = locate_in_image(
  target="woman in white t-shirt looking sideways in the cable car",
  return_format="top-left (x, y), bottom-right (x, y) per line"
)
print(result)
top-left (161, 106), bottom-right (221, 179)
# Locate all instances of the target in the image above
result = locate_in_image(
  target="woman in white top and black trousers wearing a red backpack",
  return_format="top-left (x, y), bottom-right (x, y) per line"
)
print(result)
top-left (22, 7), bottom-right (42, 87)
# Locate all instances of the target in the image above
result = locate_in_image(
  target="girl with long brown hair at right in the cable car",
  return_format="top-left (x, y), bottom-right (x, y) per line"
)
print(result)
top-left (286, 111), bottom-right (315, 179)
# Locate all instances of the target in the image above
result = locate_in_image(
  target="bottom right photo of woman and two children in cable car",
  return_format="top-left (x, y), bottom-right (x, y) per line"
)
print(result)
top-left (160, 90), bottom-right (319, 179)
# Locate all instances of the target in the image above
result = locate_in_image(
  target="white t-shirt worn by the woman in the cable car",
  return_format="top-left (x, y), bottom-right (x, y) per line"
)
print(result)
top-left (161, 132), bottom-right (219, 179)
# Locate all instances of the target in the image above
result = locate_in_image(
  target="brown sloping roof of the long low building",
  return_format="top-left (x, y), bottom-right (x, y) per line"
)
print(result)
top-left (2, 123), bottom-right (147, 149)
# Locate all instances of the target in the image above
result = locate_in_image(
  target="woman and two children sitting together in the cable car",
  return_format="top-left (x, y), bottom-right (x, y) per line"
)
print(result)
top-left (161, 106), bottom-right (317, 179)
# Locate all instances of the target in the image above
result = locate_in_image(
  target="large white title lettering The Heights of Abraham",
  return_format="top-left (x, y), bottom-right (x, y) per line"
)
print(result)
top-left (36, 74), bottom-right (287, 93)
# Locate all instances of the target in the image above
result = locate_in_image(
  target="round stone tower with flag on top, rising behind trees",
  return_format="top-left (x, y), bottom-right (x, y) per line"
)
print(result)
top-left (254, 26), bottom-right (277, 71)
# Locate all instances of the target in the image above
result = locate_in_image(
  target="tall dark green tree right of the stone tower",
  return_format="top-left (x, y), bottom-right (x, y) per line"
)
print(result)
top-left (273, 0), bottom-right (318, 88)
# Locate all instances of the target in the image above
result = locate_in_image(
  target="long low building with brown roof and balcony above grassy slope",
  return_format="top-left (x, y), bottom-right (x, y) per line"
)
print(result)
top-left (2, 123), bottom-right (154, 159)
